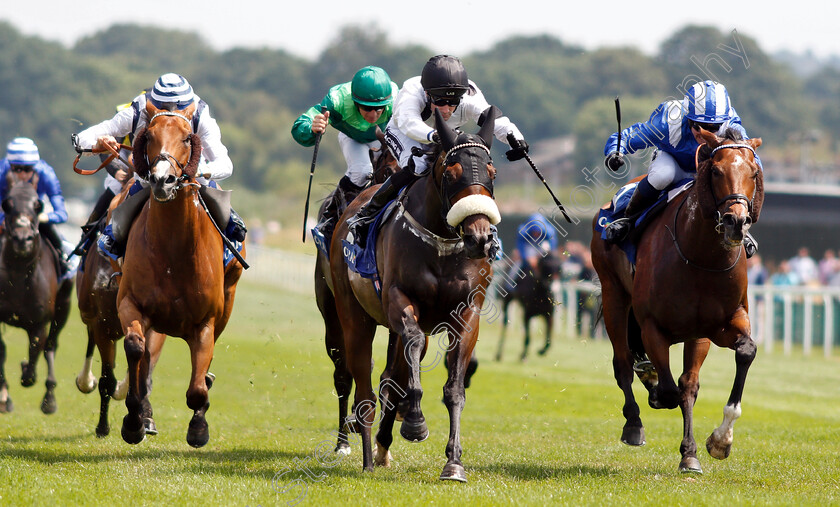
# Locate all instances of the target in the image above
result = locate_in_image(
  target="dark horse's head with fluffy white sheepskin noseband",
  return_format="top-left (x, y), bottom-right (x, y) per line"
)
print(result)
top-left (434, 106), bottom-right (502, 259)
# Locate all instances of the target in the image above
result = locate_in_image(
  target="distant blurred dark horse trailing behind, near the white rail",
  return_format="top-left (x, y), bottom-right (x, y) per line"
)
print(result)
top-left (496, 252), bottom-right (560, 361)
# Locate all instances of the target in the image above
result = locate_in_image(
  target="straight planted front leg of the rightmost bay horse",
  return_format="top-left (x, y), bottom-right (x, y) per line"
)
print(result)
top-left (679, 338), bottom-right (710, 473)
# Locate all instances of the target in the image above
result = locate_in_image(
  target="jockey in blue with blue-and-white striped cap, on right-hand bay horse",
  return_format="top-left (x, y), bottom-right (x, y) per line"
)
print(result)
top-left (604, 81), bottom-right (761, 257)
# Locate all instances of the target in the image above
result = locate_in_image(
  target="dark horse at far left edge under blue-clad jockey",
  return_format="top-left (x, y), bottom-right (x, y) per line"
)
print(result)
top-left (0, 178), bottom-right (73, 414)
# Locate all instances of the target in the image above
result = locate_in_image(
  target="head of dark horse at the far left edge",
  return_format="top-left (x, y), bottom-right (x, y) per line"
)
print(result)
top-left (3, 181), bottom-right (44, 257)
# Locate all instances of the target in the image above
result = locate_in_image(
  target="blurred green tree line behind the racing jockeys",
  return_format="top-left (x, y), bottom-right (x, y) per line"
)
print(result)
top-left (0, 22), bottom-right (840, 219)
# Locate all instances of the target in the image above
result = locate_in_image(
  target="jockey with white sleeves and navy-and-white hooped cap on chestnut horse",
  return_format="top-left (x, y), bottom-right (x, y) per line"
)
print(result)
top-left (74, 73), bottom-right (247, 260)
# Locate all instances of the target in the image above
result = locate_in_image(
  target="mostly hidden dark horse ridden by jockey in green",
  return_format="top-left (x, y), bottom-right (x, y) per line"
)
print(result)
top-left (315, 138), bottom-right (400, 454)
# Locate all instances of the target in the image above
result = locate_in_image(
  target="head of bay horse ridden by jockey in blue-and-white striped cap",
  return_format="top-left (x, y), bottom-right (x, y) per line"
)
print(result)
top-left (696, 129), bottom-right (764, 247)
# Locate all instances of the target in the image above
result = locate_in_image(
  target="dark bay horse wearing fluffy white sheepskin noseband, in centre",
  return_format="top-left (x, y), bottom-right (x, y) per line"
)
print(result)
top-left (330, 107), bottom-right (501, 482)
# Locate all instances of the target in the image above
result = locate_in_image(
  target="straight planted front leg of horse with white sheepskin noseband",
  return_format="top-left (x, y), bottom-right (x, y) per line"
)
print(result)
top-left (440, 322), bottom-right (478, 482)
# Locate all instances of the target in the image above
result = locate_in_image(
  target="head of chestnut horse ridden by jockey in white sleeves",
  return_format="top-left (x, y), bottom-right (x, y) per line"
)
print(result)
top-left (134, 101), bottom-right (201, 201)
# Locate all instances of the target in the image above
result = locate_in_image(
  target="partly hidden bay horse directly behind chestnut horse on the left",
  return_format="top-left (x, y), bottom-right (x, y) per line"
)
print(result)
top-left (76, 179), bottom-right (166, 437)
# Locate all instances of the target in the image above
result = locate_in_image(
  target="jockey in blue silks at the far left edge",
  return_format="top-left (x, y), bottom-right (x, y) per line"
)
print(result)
top-left (0, 137), bottom-right (69, 276)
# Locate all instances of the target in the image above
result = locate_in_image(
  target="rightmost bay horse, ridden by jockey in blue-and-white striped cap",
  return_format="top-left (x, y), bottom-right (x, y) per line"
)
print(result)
top-left (591, 130), bottom-right (764, 473)
